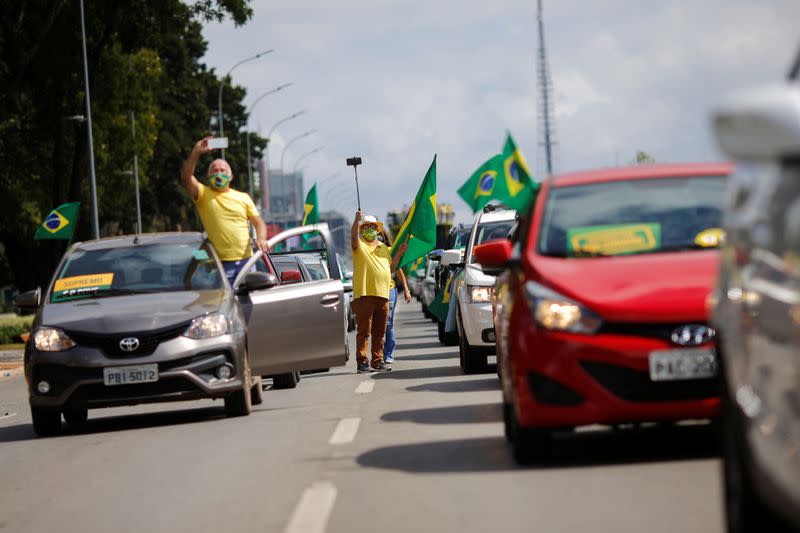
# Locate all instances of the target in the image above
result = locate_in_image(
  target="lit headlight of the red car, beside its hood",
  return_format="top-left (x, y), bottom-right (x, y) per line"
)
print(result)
top-left (525, 281), bottom-right (603, 335)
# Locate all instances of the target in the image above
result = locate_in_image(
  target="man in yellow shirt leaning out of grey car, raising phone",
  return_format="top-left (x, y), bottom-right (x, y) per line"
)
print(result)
top-left (181, 137), bottom-right (267, 284)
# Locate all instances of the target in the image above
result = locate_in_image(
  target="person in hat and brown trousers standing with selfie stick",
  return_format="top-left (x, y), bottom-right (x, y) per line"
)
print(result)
top-left (350, 210), bottom-right (407, 373)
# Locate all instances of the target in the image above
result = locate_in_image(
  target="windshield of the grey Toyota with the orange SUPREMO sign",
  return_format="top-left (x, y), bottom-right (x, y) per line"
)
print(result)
top-left (51, 243), bottom-right (223, 302)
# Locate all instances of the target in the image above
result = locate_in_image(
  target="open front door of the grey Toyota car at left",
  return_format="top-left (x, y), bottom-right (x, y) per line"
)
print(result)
top-left (233, 224), bottom-right (348, 376)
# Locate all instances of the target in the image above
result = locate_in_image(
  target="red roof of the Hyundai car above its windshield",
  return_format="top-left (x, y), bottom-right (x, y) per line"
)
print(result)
top-left (550, 163), bottom-right (733, 187)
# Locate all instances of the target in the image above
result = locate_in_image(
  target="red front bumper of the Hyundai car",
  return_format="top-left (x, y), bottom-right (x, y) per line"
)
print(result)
top-left (508, 313), bottom-right (720, 427)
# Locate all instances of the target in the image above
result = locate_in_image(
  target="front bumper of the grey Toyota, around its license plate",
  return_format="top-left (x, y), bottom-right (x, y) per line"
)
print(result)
top-left (25, 334), bottom-right (245, 410)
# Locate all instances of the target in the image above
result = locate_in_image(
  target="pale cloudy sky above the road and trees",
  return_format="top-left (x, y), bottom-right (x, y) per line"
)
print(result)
top-left (198, 0), bottom-right (800, 222)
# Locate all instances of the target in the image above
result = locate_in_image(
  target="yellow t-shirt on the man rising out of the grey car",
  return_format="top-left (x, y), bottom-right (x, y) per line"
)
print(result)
top-left (194, 183), bottom-right (258, 261)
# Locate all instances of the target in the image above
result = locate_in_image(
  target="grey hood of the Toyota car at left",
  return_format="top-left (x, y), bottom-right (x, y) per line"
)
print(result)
top-left (39, 290), bottom-right (226, 333)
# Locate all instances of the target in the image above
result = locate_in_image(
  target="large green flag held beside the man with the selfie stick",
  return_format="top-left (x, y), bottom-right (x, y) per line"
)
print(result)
top-left (392, 156), bottom-right (436, 268)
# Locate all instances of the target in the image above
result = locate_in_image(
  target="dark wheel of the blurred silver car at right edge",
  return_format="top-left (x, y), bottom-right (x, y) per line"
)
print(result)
top-left (722, 376), bottom-right (789, 533)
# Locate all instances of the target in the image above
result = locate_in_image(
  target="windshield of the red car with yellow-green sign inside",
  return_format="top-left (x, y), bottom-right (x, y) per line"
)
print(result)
top-left (539, 176), bottom-right (725, 257)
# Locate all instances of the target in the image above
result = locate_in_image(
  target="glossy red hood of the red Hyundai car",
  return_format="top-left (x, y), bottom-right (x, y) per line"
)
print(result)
top-left (533, 250), bottom-right (719, 322)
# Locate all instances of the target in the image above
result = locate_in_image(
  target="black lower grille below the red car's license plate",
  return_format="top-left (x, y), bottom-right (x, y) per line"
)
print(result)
top-left (580, 361), bottom-right (719, 402)
